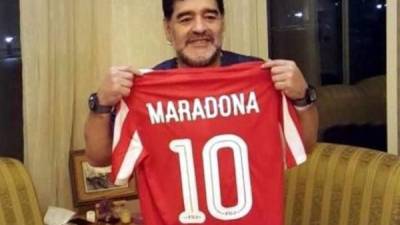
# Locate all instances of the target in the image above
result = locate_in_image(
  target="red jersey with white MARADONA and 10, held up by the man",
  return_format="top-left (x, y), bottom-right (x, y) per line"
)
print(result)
top-left (111, 62), bottom-right (306, 225)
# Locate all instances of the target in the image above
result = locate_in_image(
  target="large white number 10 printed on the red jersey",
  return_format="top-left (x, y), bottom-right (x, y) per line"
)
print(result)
top-left (169, 134), bottom-right (253, 224)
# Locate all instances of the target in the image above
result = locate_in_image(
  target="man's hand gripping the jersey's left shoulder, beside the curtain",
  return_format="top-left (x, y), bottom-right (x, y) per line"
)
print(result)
top-left (97, 66), bottom-right (142, 106)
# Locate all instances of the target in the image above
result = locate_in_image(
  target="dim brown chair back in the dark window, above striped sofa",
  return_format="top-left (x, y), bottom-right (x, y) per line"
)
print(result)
top-left (317, 76), bottom-right (386, 132)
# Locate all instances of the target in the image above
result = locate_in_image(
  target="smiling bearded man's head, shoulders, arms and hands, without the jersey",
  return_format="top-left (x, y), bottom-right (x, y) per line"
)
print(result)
top-left (85, 0), bottom-right (318, 166)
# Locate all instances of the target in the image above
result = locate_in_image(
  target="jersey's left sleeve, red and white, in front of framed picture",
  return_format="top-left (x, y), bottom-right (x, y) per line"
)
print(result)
top-left (110, 100), bottom-right (144, 185)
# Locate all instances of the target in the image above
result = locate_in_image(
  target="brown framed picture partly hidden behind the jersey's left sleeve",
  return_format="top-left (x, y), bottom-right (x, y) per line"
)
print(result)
top-left (69, 150), bottom-right (137, 207)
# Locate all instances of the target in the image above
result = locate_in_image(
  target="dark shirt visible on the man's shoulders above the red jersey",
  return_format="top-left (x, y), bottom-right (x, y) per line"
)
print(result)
top-left (153, 51), bottom-right (262, 70)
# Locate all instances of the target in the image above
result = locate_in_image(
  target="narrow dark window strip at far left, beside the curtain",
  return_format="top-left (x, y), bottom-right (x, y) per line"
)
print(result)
top-left (0, 0), bottom-right (23, 161)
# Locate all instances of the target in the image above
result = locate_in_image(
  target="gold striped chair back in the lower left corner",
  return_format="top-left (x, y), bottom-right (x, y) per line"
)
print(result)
top-left (0, 157), bottom-right (43, 225)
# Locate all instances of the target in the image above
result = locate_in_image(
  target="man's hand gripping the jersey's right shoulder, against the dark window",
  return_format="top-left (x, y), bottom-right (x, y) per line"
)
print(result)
top-left (261, 59), bottom-right (307, 100)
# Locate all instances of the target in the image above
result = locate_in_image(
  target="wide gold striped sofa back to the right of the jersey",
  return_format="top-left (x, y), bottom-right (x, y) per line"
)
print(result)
top-left (285, 143), bottom-right (400, 225)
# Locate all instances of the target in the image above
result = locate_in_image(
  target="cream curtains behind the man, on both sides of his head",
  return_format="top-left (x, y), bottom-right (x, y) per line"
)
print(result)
top-left (20, 0), bottom-right (267, 212)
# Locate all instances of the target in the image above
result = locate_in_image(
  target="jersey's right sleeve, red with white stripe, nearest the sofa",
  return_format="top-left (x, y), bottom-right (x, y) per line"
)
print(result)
top-left (282, 93), bottom-right (307, 168)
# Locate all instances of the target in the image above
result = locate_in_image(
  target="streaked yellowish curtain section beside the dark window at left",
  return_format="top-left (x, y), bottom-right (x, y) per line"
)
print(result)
top-left (20, 0), bottom-right (111, 212)
